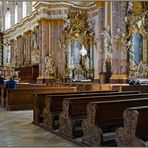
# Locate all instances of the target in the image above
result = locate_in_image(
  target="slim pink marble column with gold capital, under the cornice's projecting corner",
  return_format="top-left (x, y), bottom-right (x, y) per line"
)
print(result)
top-left (38, 18), bottom-right (49, 78)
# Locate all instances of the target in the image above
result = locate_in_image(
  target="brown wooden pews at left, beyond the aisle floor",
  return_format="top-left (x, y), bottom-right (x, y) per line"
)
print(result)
top-left (0, 84), bottom-right (76, 111)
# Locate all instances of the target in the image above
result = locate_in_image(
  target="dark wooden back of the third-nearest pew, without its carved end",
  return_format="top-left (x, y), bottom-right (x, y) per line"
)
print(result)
top-left (66, 93), bottom-right (148, 117)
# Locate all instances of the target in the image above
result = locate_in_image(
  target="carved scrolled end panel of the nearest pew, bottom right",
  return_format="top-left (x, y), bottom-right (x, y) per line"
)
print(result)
top-left (115, 108), bottom-right (146, 147)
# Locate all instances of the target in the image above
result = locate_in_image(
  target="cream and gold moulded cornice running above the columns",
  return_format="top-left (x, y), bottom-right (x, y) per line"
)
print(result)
top-left (4, 1), bottom-right (96, 40)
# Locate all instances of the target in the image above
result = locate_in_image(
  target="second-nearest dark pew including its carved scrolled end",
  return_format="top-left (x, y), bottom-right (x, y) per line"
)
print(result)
top-left (82, 96), bottom-right (148, 146)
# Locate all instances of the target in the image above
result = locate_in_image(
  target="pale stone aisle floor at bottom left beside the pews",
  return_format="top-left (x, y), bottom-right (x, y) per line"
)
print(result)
top-left (0, 108), bottom-right (78, 147)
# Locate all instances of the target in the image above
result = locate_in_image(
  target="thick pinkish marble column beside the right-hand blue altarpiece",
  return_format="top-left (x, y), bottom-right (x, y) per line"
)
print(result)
top-left (110, 1), bottom-right (128, 83)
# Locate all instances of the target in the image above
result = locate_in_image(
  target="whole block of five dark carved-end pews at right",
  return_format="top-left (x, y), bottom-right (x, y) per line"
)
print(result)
top-left (33, 91), bottom-right (148, 146)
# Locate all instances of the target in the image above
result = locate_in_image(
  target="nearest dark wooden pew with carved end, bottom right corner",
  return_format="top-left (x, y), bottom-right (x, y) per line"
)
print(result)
top-left (115, 106), bottom-right (148, 147)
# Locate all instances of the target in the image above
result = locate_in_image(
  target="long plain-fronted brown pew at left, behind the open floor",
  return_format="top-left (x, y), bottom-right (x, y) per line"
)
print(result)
top-left (3, 87), bottom-right (76, 110)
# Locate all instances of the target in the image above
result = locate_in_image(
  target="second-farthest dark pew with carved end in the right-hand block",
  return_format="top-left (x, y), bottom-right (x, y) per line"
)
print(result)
top-left (40, 91), bottom-right (139, 129)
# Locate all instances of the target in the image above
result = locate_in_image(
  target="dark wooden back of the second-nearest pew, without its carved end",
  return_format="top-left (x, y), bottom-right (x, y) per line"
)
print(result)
top-left (88, 97), bottom-right (148, 128)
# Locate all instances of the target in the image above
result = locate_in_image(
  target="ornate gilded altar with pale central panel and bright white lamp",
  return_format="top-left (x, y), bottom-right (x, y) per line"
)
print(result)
top-left (59, 8), bottom-right (94, 81)
